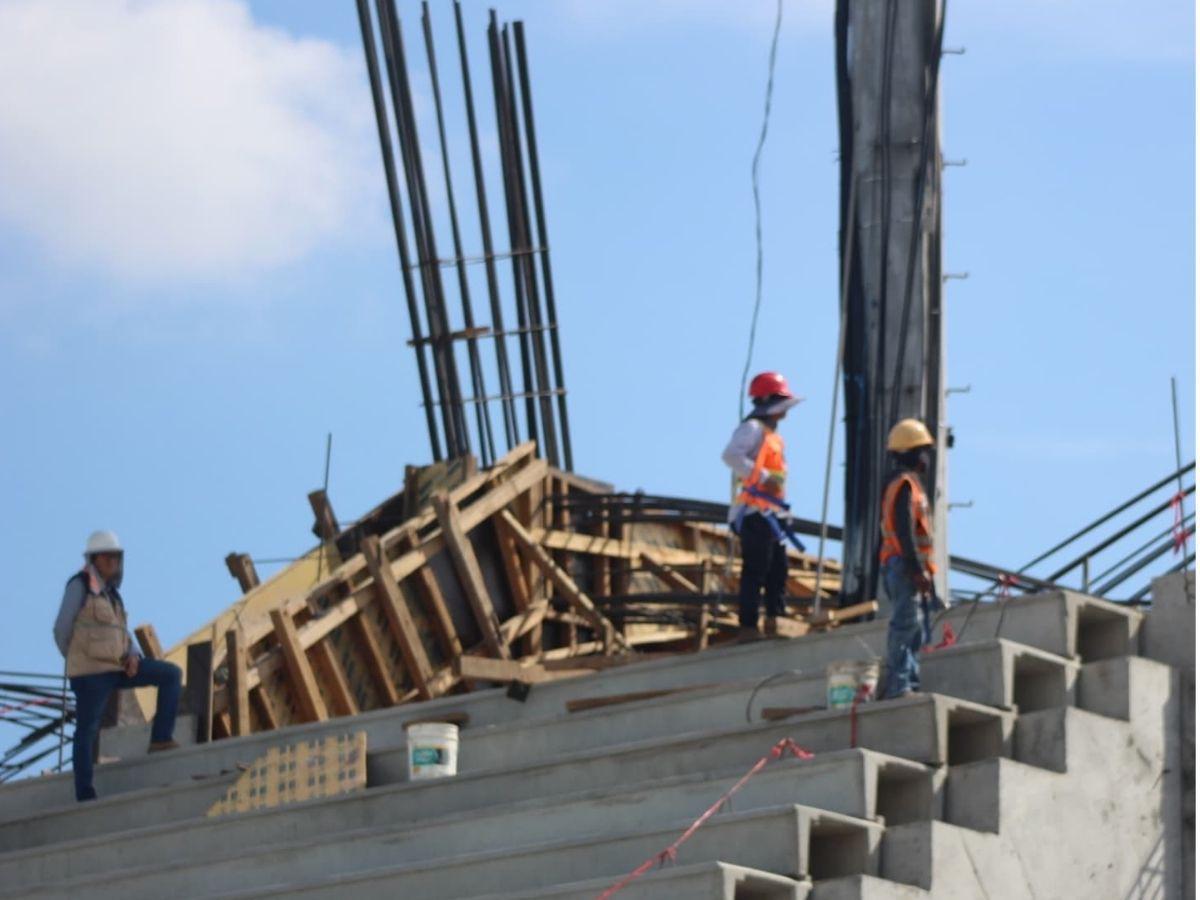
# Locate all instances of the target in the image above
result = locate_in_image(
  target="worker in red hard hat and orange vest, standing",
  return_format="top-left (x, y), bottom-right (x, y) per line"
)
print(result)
top-left (721, 372), bottom-right (803, 641)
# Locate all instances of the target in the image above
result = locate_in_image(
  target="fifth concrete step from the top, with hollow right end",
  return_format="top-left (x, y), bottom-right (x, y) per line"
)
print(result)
top-left (201, 806), bottom-right (883, 900)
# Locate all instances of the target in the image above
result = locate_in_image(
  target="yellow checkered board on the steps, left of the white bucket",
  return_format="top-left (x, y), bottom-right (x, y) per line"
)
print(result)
top-left (205, 731), bottom-right (367, 818)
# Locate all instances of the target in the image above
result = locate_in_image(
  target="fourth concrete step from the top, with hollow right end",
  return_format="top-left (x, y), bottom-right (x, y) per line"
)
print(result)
top-left (0, 750), bottom-right (926, 892)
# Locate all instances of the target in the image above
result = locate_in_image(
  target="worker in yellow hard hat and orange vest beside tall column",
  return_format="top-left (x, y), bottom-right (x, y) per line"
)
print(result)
top-left (880, 419), bottom-right (941, 700)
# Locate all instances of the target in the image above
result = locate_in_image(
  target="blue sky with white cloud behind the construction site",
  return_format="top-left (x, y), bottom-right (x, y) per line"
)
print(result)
top-left (0, 0), bottom-right (1195, 705)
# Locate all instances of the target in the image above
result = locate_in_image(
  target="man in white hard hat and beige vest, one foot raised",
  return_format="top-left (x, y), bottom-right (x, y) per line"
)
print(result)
top-left (54, 532), bottom-right (184, 800)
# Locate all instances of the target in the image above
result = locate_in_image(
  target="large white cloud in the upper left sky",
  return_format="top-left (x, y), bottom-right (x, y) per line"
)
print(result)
top-left (0, 0), bottom-right (377, 282)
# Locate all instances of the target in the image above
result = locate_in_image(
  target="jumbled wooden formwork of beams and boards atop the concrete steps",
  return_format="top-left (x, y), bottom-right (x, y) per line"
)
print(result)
top-left (137, 443), bottom-right (864, 740)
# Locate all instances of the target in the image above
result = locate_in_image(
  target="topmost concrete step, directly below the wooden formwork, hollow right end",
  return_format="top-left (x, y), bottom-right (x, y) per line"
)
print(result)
top-left (0, 592), bottom-right (1141, 821)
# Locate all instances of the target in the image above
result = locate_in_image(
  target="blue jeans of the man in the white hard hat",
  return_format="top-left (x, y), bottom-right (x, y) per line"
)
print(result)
top-left (71, 659), bottom-right (184, 800)
